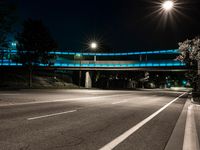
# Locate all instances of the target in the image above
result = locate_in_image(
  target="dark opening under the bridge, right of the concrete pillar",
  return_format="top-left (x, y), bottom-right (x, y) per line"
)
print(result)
top-left (91, 71), bottom-right (190, 89)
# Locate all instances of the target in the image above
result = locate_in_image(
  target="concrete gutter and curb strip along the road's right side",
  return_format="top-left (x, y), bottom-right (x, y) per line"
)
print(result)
top-left (165, 99), bottom-right (200, 150)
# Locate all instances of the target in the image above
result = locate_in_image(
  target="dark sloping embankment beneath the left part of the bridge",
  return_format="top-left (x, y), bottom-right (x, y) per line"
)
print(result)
top-left (0, 69), bottom-right (78, 89)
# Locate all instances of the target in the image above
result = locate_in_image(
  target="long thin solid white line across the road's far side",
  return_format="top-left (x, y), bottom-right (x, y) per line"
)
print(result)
top-left (0, 94), bottom-right (132, 107)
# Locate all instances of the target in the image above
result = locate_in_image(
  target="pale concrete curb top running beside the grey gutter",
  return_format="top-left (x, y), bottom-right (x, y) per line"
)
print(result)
top-left (183, 104), bottom-right (199, 150)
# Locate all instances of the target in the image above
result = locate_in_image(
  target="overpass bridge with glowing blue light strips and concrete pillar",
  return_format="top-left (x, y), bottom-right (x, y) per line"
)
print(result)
top-left (0, 49), bottom-right (187, 87)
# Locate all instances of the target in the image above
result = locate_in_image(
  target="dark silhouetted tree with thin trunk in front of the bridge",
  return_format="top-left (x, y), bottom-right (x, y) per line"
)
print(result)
top-left (16, 19), bottom-right (57, 87)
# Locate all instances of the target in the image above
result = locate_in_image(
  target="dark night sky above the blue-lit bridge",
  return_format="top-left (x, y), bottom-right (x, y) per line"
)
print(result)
top-left (16, 0), bottom-right (200, 51)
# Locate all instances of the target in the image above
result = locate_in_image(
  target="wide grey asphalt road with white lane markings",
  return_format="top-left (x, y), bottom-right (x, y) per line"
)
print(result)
top-left (0, 90), bottom-right (187, 150)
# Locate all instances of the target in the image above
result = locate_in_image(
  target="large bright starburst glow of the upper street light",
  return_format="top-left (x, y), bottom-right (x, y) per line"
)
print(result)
top-left (143, 0), bottom-right (189, 30)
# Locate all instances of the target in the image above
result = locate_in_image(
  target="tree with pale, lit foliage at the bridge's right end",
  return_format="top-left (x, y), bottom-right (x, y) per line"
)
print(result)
top-left (178, 37), bottom-right (200, 94)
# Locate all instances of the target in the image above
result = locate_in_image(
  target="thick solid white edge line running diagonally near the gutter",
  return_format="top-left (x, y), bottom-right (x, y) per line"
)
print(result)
top-left (99, 92), bottom-right (187, 150)
